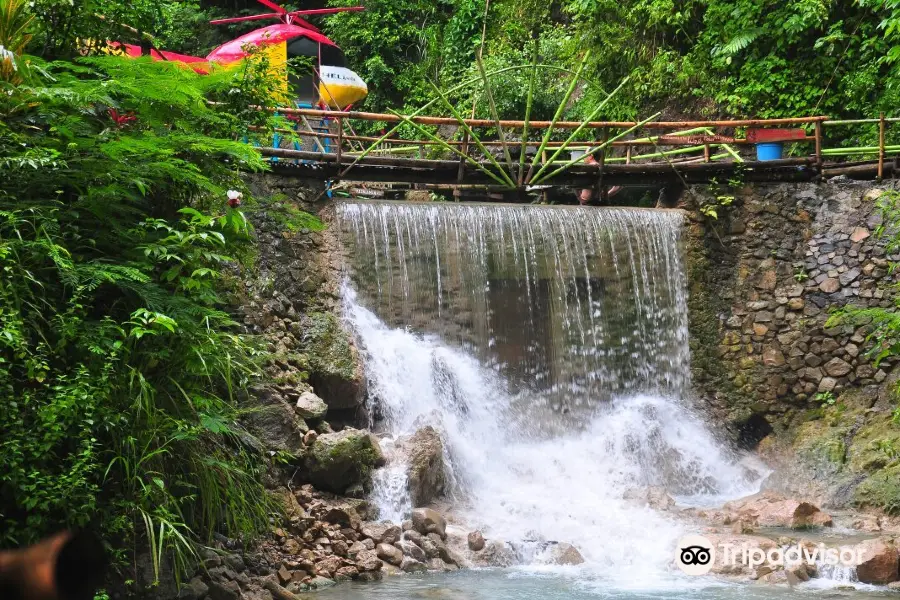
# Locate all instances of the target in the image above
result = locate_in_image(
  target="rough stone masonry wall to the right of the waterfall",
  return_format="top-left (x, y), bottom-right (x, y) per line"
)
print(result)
top-left (683, 181), bottom-right (900, 446)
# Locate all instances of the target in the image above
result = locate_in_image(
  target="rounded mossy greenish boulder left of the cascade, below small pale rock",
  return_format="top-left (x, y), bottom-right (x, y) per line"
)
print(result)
top-left (302, 428), bottom-right (384, 494)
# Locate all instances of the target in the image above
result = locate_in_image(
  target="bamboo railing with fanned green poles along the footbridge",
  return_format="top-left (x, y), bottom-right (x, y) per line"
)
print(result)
top-left (263, 108), bottom-right (900, 189)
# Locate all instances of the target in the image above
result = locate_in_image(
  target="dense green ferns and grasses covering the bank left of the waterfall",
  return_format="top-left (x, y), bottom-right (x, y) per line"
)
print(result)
top-left (0, 42), bottom-right (324, 584)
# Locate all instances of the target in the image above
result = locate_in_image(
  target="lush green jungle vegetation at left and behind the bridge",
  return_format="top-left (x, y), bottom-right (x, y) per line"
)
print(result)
top-left (0, 0), bottom-right (900, 592)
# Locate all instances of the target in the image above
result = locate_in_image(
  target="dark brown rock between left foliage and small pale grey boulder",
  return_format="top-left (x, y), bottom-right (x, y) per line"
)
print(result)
top-left (243, 388), bottom-right (309, 454)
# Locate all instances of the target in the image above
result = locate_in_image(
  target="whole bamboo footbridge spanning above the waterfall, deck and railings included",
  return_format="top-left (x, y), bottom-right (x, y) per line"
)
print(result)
top-left (260, 108), bottom-right (900, 197)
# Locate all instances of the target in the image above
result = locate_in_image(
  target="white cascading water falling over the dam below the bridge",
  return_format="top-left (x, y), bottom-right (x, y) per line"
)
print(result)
top-left (338, 203), bottom-right (758, 580)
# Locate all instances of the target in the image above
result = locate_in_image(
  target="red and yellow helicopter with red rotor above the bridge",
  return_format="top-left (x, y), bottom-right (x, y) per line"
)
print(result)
top-left (115, 0), bottom-right (369, 110)
